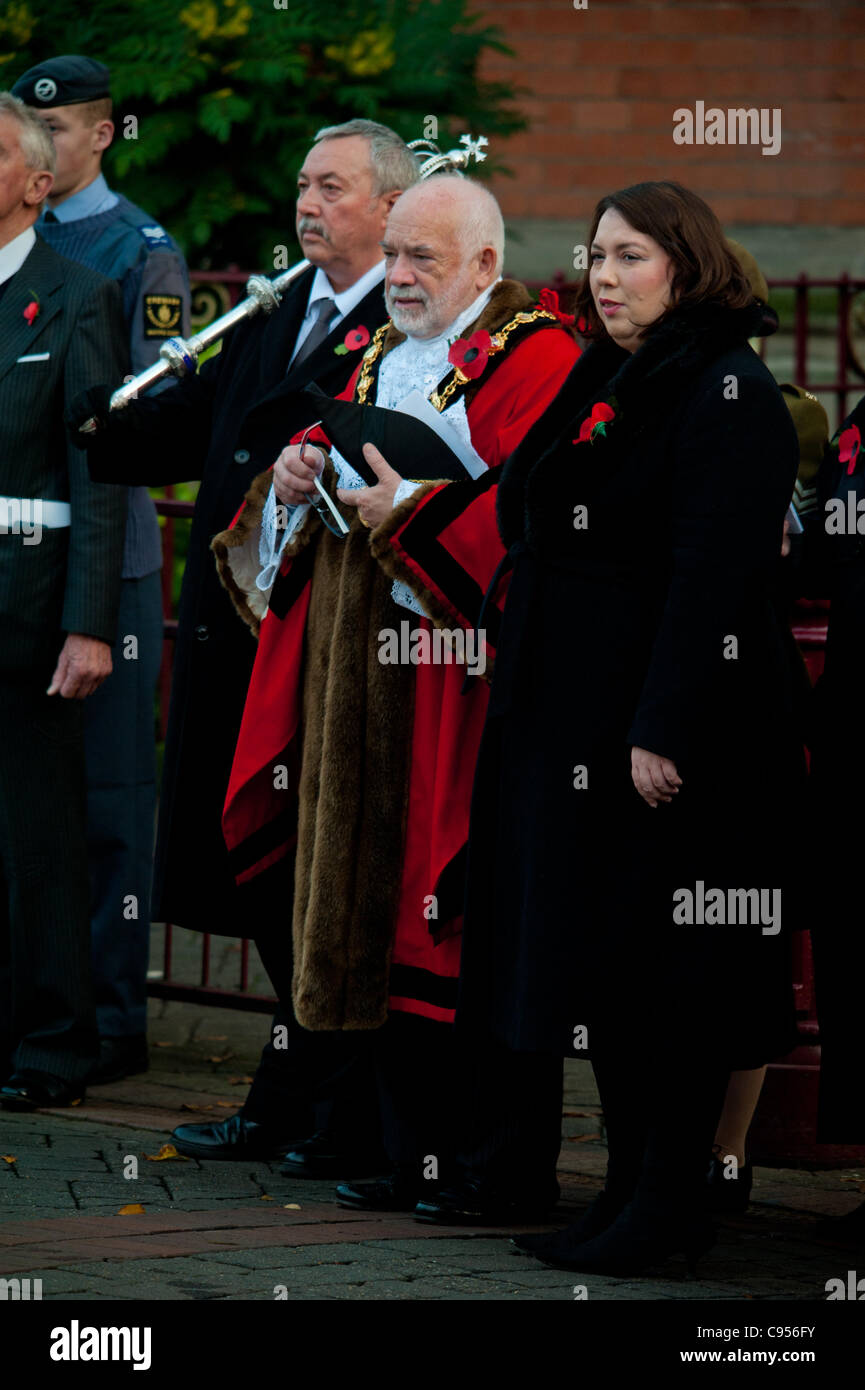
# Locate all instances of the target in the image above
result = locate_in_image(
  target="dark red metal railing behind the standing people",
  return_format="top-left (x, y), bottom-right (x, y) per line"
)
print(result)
top-left (147, 267), bottom-right (865, 1033)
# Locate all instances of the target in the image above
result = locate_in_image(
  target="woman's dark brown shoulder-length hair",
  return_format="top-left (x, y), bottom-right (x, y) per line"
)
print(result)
top-left (576, 181), bottom-right (754, 338)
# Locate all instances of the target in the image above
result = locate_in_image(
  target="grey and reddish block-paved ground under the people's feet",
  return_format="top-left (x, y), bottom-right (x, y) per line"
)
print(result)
top-left (0, 942), bottom-right (865, 1301)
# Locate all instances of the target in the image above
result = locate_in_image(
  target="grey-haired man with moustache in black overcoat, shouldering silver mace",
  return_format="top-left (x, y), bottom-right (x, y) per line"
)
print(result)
top-left (76, 121), bottom-right (419, 1175)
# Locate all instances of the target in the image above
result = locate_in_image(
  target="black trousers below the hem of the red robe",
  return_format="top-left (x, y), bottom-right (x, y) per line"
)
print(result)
top-left (375, 1012), bottom-right (563, 1194)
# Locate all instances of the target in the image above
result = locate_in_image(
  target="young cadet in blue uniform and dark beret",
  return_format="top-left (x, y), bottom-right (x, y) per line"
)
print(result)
top-left (14, 54), bottom-right (189, 1081)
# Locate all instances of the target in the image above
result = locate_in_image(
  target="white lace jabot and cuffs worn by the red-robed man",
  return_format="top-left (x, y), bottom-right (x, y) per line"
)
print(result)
top-left (256, 281), bottom-right (498, 613)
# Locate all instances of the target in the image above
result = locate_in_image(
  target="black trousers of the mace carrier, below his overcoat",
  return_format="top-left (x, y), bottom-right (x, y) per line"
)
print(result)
top-left (242, 924), bottom-right (381, 1155)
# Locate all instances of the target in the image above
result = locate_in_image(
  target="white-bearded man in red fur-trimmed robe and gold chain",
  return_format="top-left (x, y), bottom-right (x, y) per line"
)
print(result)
top-left (214, 170), bottom-right (579, 1218)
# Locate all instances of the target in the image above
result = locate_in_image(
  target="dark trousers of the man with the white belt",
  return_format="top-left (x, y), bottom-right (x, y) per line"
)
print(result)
top-left (0, 673), bottom-right (99, 1081)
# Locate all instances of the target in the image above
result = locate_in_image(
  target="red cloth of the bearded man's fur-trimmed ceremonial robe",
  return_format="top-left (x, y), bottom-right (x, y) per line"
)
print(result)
top-left (214, 307), bottom-right (579, 1027)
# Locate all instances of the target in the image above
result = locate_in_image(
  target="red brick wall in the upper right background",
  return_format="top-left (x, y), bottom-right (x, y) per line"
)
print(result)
top-left (476, 0), bottom-right (865, 228)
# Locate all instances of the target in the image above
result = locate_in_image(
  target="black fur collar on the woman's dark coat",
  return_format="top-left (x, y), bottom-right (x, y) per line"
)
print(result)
top-left (496, 302), bottom-right (763, 546)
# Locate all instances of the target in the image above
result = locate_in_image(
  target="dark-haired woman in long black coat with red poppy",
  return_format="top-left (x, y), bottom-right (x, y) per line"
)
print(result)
top-left (460, 183), bottom-right (802, 1272)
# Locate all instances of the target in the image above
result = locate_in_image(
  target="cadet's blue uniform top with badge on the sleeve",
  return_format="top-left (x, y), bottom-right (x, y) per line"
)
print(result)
top-left (36, 174), bottom-right (189, 580)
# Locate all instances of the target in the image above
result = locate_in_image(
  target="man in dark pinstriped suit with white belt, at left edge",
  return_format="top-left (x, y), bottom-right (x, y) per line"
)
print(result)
top-left (0, 93), bottom-right (127, 1109)
